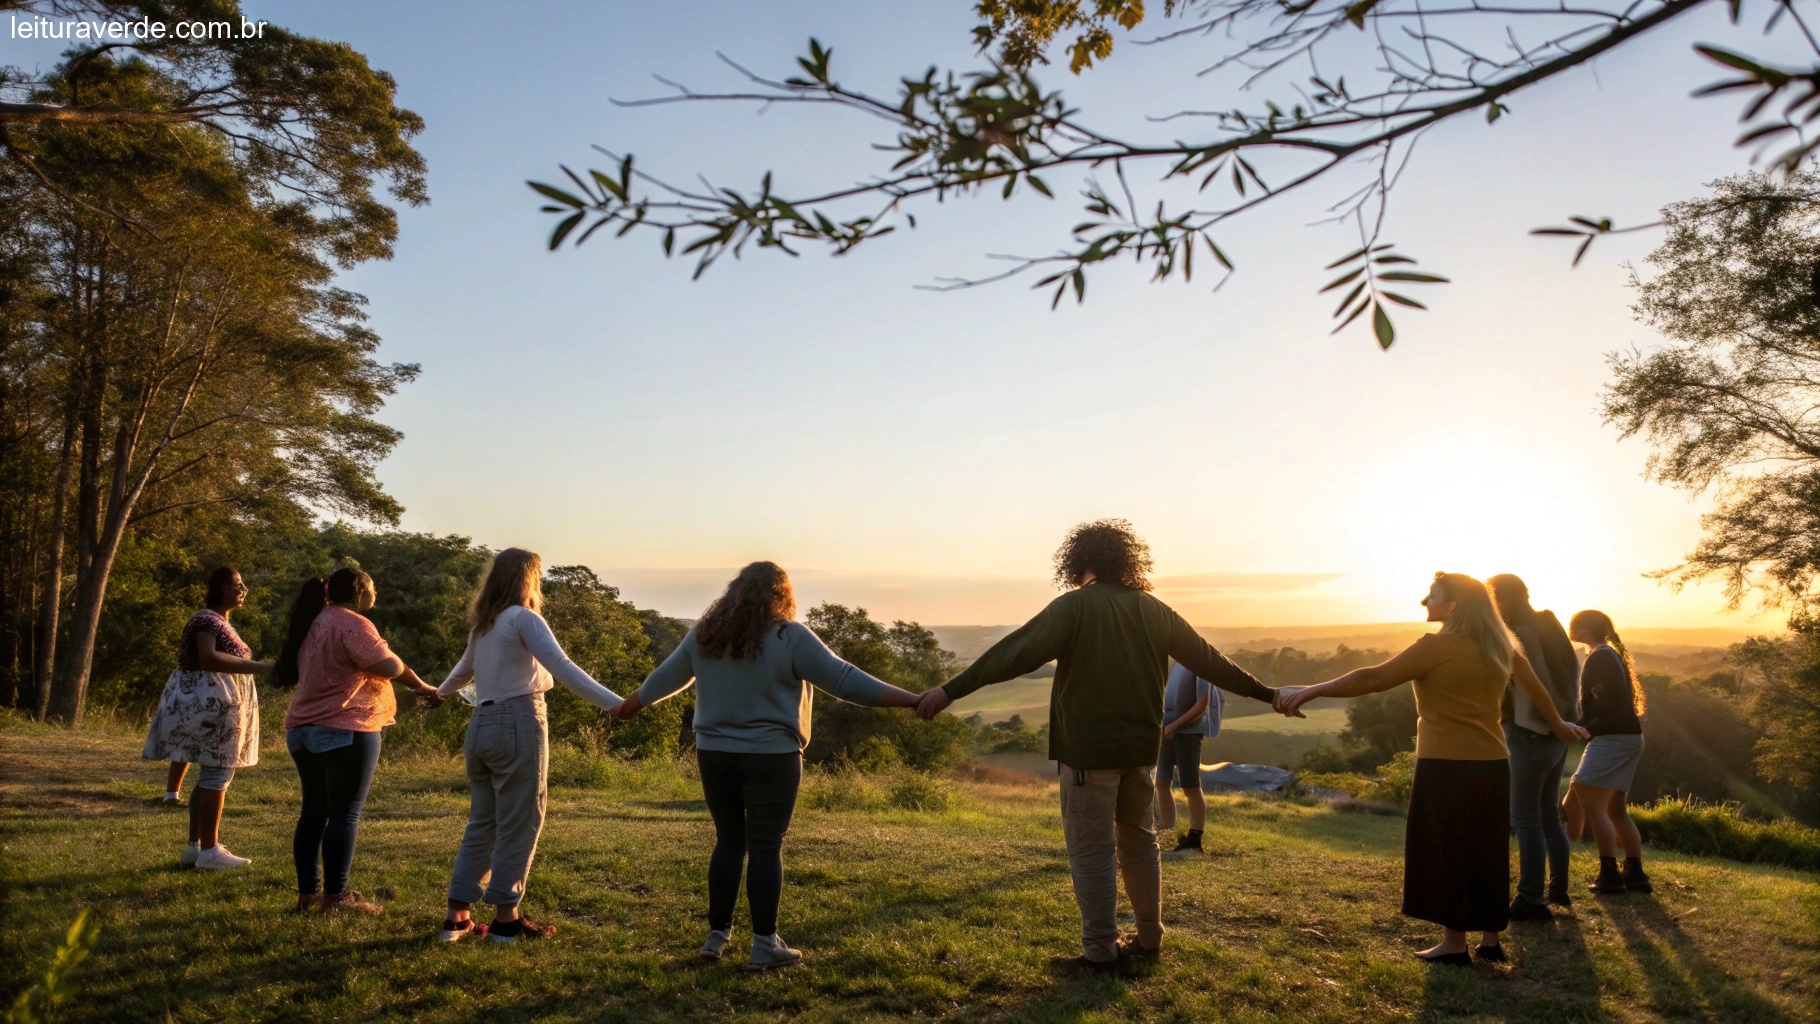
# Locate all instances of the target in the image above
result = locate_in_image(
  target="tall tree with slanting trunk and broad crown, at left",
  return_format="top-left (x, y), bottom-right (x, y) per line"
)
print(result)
top-left (15, 55), bottom-right (417, 722)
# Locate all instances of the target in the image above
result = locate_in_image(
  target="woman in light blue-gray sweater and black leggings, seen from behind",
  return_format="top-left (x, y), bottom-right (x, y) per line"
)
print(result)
top-left (615, 562), bottom-right (917, 971)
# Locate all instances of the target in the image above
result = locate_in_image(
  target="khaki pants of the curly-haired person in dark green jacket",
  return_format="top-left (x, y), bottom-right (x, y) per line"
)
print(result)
top-left (1061, 764), bottom-right (1163, 962)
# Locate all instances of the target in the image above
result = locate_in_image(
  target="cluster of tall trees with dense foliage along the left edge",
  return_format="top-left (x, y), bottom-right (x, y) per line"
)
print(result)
top-left (0, 0), bottom-right (426, 722)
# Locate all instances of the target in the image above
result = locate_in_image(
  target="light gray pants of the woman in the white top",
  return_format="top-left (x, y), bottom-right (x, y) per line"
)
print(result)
top-left (450, 693), bottom-right (550, 906)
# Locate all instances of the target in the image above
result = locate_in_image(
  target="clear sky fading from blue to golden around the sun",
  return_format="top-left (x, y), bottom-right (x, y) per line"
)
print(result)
top-left (0, 0), bottom-right (1805, 629)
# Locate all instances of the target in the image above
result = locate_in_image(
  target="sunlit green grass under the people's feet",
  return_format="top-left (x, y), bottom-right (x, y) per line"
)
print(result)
top-left (0, 720), bottom-right (1820, 1024)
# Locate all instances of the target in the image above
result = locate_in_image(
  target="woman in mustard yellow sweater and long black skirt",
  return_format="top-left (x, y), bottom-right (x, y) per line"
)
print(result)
top-left (1276, 573), bottom-right (1585, 966)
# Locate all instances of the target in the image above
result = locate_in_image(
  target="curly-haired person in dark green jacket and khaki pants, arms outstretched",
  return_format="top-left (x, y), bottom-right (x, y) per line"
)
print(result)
top-left (917, 520), bottom-right (1276, 969)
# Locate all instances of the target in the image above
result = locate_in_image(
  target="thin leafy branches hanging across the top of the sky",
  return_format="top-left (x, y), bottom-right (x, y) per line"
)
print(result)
top-left (531, 0), bottom-right (1820, 347)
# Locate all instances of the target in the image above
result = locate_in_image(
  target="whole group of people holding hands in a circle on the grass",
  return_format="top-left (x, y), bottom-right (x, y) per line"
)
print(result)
top-left (144, 520), bottom-right (1649, 971)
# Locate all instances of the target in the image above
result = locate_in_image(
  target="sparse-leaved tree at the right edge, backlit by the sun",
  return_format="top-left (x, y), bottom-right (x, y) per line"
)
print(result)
top-left (1603, 167), bottom-right (1820, 814)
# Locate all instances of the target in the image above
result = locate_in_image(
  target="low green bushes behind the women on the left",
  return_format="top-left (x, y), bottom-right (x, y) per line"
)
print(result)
top-left (76, 524), bottom-right (693, 757)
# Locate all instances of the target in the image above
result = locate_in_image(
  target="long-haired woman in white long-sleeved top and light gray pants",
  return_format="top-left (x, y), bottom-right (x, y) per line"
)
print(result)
top-left (437, 547), bottom-right (621, 942)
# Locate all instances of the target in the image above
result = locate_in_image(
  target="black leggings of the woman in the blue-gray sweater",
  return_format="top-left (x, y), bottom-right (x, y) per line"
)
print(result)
top-left (695, 749), bottom-right (803, 935)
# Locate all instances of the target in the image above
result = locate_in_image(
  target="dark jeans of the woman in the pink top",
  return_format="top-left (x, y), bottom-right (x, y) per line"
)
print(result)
top-left (291, 731), bottom-right (380, 897)
